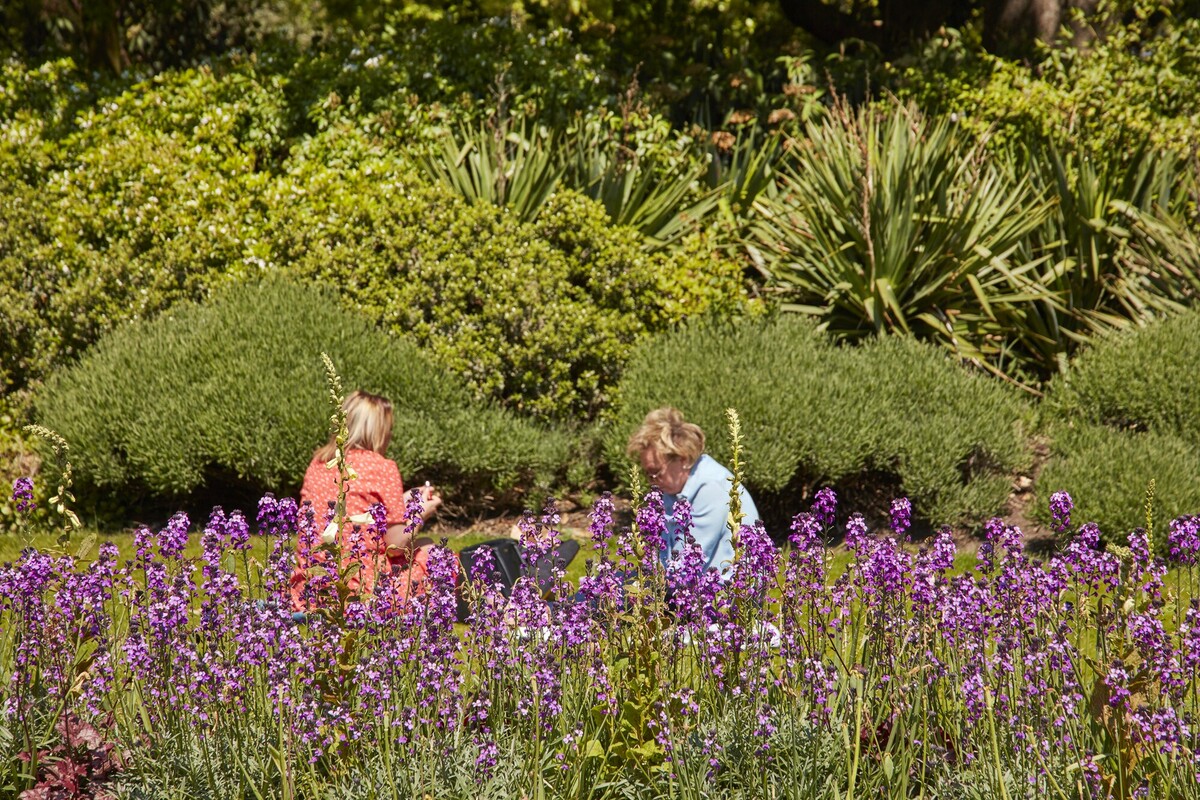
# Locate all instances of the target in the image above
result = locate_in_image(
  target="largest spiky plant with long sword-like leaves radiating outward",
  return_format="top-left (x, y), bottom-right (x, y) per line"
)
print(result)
top-left (749, 99), bottom-right (1055, 379)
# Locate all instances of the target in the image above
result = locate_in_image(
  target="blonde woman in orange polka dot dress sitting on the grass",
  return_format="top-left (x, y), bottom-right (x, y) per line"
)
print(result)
top-left (292, 391), bottom-right (442, 610)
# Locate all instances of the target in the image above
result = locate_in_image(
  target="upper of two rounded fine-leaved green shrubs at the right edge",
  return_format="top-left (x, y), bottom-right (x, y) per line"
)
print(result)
top-left (1050, 311), bottom-right (1200, 447)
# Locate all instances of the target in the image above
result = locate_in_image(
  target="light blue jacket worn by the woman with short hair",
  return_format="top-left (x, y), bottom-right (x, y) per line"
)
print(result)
top-left (659, 455), bottom-right (760, 575)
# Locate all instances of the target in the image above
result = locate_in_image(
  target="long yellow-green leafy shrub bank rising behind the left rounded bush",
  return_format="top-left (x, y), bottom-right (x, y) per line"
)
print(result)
top-left (0, 47), bottom-right (744, 419)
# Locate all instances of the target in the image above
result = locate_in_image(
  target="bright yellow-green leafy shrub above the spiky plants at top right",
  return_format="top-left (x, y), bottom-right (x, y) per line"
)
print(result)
top-left (897, 13), bottom-right (1200, 160)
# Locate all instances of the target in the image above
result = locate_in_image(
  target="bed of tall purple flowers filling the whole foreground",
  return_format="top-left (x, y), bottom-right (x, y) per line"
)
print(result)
top-left (0, 483), bottom-right (1200, 799)
